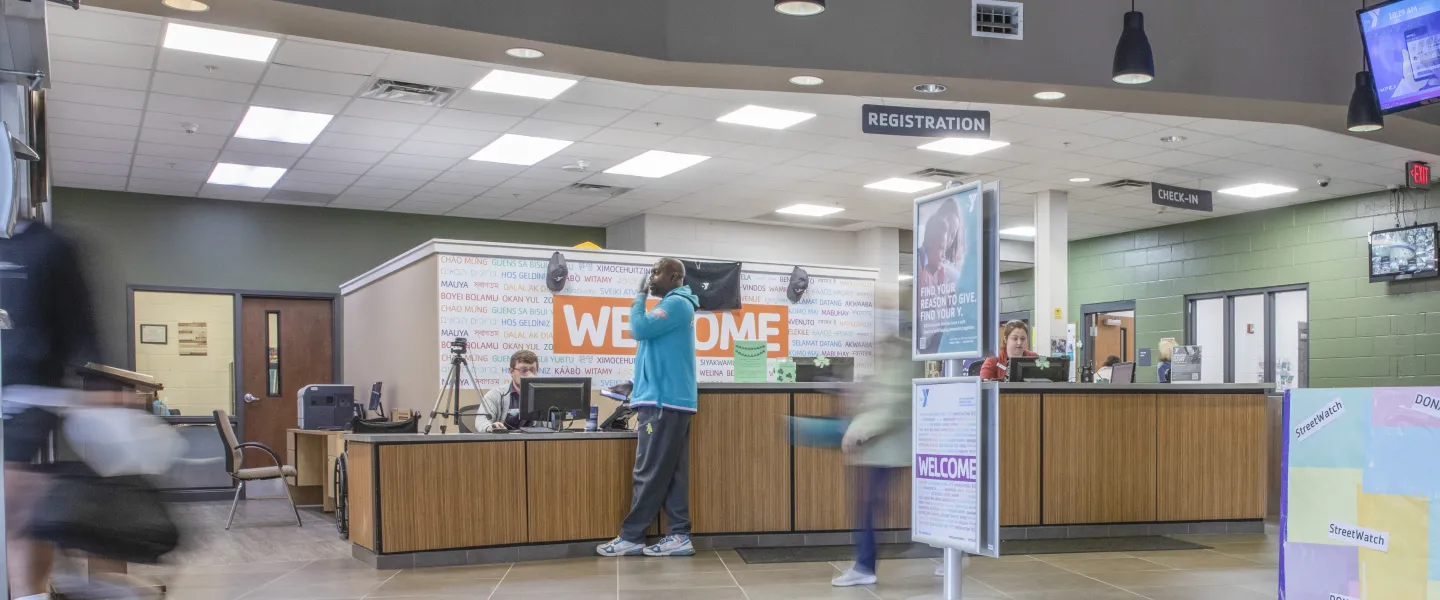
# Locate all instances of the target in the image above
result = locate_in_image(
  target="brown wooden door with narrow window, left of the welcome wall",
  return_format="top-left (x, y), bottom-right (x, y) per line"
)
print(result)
top-left (240, 298), bottom-right (334, 453)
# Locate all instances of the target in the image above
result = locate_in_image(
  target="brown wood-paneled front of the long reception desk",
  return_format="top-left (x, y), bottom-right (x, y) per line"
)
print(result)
top-left (347, 384), bottom-right (1269, 568)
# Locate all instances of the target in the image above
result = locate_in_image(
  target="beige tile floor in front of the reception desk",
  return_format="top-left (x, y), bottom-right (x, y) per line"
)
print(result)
top-left (132, 505), bottom-right (1279, 600)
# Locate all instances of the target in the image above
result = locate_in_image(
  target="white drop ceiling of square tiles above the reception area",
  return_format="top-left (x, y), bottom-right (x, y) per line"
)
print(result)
top-left (39, 7), bottom-right (1440, 239)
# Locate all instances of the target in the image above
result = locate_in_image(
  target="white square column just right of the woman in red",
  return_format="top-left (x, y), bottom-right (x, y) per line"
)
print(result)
top-left (1031, 190), bottom-right (1071, 355)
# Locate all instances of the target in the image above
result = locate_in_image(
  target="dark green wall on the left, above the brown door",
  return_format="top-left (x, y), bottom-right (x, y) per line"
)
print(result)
top-left (53, 188), bottom-right (605, 365)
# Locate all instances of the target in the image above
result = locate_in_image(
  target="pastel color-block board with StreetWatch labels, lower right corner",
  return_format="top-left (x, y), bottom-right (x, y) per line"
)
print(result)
top-left (1280, 387), bottom-right (1440, 600)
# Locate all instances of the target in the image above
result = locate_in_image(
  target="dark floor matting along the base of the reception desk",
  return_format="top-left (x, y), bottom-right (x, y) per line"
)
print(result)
top-left (734, 535), bottom-right (1210, 564)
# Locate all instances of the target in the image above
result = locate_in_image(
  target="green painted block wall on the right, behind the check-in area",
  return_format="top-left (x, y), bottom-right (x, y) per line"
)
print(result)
top-left (1001, 193), bottom-right (1440, 387)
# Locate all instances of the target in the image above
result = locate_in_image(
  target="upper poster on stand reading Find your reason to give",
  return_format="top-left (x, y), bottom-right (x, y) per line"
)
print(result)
top-left (913, 183), bottom-right (985, 360)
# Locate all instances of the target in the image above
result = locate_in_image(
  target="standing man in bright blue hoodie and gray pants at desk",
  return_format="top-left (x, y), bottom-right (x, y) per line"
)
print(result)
top-left (595, 259), bottom-right (700, 557)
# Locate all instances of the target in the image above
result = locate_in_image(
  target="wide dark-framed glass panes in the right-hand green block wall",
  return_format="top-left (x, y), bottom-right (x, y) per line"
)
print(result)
top-left (1187, 285), bottom-right (1309, 391)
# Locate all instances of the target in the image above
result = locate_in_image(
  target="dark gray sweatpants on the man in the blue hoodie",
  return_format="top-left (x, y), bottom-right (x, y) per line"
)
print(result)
top-left (621, 406), bottom-right (693, 544)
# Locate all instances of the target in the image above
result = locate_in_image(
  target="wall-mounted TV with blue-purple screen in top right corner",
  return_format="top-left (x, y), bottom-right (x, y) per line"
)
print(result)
top-left (1356, 0), bottom-right (1440, 115)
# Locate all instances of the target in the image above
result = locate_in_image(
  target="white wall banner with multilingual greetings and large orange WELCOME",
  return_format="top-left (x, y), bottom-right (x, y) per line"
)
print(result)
top-left (436, 255), bottom-right (874, 388)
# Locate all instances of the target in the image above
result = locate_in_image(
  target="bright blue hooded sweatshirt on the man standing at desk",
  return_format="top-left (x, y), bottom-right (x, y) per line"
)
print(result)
top-left (631, 285), bottom-right (700, 413)
